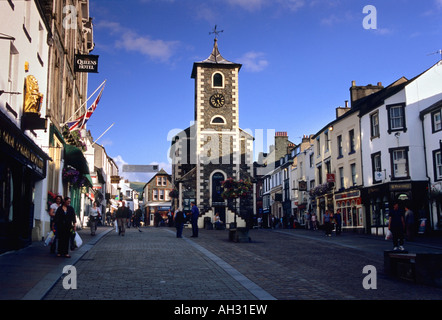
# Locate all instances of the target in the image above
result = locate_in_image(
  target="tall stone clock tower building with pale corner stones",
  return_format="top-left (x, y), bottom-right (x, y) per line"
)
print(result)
top-left (170, 38), bottom-right (254, 227)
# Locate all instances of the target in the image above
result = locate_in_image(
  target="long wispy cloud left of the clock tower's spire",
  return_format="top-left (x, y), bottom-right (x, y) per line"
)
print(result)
top-left (96, 21), bottom-right (179, 62)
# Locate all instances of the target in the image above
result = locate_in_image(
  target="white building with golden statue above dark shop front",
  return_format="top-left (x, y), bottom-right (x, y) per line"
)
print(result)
top-left (0, 1), bottom-right (50, 252)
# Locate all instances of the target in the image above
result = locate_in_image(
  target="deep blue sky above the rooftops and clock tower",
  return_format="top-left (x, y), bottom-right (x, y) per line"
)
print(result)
top-left (87, 0), bottom-right (442, 181)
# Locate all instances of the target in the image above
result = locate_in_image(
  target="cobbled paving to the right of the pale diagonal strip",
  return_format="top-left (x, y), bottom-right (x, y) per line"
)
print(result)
top-left (195, 230), bottom-right (442, 300)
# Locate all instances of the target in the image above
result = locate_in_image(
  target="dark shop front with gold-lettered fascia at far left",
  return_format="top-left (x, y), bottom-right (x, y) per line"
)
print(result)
top-left (0, 112), bottom-right (49, 253)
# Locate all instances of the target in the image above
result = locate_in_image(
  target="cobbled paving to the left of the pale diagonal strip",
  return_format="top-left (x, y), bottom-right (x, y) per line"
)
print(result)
top-left (45, 228), bottom-right (256, 300)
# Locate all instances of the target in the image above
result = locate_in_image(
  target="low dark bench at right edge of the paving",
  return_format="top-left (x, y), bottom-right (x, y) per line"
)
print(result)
top-left (384, 251), bottom-right (442, 288)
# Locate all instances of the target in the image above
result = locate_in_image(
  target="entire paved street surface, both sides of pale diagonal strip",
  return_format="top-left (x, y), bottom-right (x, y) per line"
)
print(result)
top-left (44, 227), bottom-right (442, 301)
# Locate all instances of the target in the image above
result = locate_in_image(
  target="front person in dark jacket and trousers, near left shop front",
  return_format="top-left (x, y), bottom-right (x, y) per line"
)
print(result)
top-left (54, 197), bottom-right (77, 258)
